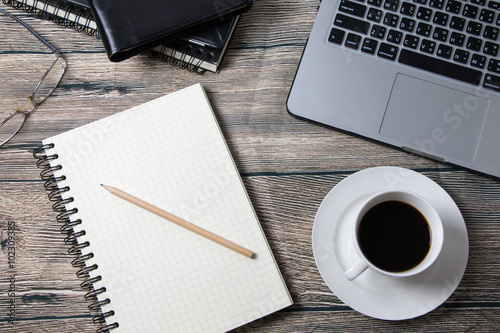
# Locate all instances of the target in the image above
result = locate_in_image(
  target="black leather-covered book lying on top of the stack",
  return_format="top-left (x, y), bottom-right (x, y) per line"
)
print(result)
top-left (88, 0), bottom-right (252, 62)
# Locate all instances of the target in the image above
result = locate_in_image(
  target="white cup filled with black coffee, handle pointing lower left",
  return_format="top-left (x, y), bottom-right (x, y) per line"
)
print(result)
top-left (344, 190), bottom-right (443, 281)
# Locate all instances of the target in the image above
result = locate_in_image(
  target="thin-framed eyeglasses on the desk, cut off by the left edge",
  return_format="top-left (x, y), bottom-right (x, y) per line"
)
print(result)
top-left (0, 8), bottom-right (67, 147)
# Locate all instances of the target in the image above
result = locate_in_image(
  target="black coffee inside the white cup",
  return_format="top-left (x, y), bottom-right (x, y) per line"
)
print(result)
top-left (357, 201), bottom-right (431, 272)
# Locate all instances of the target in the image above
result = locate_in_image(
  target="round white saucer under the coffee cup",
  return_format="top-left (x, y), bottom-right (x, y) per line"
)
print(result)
top-left (312, 167), bottom-right (469, 320)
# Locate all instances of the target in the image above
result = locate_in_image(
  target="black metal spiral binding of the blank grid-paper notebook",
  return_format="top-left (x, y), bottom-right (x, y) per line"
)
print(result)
top-left (33, 144), bottom-right (118, 333)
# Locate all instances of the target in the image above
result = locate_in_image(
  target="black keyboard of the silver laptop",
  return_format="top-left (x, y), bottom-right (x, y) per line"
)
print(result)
top-left (328, 0), bottom-right (500, 92)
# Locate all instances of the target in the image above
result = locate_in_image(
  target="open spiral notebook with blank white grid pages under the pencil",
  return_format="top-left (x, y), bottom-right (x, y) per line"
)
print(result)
top-left (35, 84), bottom-right (292, 332)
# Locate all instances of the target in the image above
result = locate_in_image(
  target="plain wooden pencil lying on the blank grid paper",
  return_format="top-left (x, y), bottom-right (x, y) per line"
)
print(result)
top-left (101, 184), bottom-right (255, 258)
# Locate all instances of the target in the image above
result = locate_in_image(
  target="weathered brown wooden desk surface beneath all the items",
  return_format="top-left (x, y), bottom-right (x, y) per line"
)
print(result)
top-left (0, 0), bottom-right (500, 332)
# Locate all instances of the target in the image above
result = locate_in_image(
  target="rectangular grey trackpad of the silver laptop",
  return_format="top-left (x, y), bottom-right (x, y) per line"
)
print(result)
top-left (380, 74), bottom-right (489, 162)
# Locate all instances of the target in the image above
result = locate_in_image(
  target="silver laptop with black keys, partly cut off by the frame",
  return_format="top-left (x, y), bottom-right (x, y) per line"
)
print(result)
top-left (287, 0), bottom-right (500, 177)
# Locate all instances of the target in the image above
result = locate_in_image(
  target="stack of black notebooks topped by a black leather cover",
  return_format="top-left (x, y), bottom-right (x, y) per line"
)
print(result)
top-left (2, 0), bottom-right (252, 74)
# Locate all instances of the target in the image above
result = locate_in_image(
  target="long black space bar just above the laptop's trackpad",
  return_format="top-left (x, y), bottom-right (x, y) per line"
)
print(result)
top-left (398, 49), bottom-right (482, 87)
